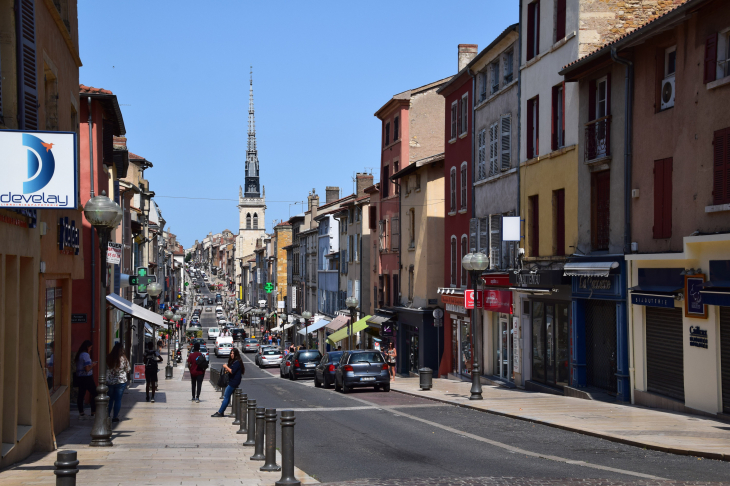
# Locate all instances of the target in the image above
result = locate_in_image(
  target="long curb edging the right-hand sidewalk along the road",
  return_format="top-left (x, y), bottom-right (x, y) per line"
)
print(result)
top-left (390, 387), bottom-right (730, 462)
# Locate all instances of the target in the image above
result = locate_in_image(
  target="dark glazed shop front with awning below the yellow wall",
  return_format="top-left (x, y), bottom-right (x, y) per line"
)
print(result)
top-left (509, 265), bottom-right (572, 394)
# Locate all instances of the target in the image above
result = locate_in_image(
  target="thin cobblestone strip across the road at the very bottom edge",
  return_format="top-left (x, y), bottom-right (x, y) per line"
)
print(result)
top-left (321, 477), bottom-right (730, 486)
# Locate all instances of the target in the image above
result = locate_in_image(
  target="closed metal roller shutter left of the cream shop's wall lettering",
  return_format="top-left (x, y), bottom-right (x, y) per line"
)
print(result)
top-left (646, 307), bottom-right (684, 402)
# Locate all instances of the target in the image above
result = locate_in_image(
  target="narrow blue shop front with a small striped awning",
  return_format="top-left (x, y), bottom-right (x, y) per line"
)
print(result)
top-left (564, 256), bottom-right (630, 401)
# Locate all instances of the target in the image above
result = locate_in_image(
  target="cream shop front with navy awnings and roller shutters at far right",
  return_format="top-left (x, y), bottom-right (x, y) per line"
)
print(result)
top-left (626, 234), bottom-right (730, 415)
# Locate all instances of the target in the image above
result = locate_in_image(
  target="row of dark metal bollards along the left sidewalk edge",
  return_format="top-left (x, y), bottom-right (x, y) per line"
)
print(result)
top-left (225, 382), bottom-right (301, 486)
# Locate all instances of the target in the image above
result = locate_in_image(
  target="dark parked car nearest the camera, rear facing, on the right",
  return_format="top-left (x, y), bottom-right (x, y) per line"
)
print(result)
top-left (335, 349), bottom-right (390, 393)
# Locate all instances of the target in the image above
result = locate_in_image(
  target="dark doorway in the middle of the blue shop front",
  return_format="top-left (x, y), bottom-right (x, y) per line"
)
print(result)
top-left (585, 300), bottom-right (617, 393)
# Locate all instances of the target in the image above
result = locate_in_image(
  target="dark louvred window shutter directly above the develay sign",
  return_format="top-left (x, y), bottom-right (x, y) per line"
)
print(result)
top-left (16, 0), bottom-right (38, 130)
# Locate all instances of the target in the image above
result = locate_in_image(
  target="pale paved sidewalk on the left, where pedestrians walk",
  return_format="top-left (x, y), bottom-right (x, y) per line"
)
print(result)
top-left (0, 365), bottom-right (317, 486)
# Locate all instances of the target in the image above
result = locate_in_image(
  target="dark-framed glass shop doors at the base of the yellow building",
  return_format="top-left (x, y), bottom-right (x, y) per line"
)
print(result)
top-left (532, 301), bottom-right (569, 386)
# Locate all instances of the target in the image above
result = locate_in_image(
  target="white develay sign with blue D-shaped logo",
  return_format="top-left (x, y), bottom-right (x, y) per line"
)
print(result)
top-left (0, 130), bottom-right (78, 209)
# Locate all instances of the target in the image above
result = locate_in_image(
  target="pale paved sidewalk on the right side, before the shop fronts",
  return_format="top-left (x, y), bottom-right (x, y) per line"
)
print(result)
top-left (391, 378), bottom-right (730, 461)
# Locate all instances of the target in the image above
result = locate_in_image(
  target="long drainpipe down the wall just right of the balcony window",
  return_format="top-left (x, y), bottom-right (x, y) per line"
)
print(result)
top-left (611, 47), bottom-right (635, 403)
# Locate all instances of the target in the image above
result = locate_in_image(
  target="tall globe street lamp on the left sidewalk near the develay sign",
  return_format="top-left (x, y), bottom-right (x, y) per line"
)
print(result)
top-left (84, 191), bottom-right (124, 447)
